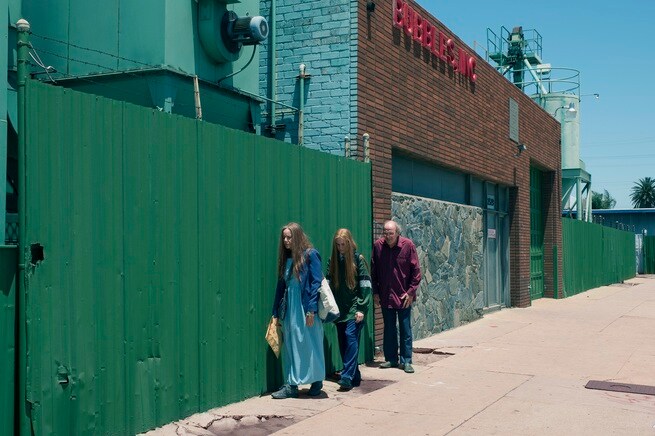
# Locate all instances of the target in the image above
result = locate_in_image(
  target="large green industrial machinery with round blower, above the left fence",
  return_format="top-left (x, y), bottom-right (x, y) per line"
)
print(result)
top-left (19, 0), bottom-right (269, 132)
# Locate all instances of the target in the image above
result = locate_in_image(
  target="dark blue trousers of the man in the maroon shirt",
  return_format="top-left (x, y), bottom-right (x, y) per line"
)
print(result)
top-left (382, 307), bottom-right (412, 364)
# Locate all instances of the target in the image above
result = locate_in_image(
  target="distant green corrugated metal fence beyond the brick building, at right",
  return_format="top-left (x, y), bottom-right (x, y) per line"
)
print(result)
top-left (562, 218), bottom-right (636, 297)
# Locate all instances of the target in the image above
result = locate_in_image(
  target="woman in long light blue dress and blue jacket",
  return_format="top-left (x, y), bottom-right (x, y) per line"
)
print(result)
top-left (272, 223), bottom-right (325, 399)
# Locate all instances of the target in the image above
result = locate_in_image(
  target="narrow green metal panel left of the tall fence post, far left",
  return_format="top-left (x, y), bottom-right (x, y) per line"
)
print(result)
top-left (0, 245), bottom-right (18, 435)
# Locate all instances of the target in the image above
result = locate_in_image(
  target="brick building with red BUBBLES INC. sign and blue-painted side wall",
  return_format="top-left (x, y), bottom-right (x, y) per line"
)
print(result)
top-left (260, 0), bottom-right (561, 339)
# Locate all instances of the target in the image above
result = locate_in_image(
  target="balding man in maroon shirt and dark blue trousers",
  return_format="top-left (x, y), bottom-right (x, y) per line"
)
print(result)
top-left (371, 221), bottom-right (421, 373)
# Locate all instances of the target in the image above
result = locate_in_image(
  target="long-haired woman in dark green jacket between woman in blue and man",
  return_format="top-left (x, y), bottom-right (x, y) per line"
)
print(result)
top-left (327, 229), bottom-right (371, 391)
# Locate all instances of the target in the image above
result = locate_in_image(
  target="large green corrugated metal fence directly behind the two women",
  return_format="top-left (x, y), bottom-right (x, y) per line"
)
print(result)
top-left (22, 82), bottom-right (372, 434)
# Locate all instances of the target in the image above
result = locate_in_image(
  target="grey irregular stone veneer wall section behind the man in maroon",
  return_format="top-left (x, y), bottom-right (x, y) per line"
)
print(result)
top-left (391, 193), bottom-right (484, 339)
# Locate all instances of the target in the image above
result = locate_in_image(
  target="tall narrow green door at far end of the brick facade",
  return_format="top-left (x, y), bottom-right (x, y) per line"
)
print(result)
top-left (530, 168), bottom-right (544, 300)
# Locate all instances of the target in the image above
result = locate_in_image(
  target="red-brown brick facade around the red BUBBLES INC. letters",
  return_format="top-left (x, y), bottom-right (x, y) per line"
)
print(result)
top-left (357, 0), bottom-right (562, 322)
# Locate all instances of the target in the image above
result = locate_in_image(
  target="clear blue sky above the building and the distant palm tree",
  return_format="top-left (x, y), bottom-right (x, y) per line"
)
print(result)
top-left (418, 0), bottom-right (655, 209)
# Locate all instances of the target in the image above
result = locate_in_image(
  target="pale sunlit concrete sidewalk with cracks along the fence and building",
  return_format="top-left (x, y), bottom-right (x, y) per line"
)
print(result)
top-left (148, 276), bottom-right (655, 435)
